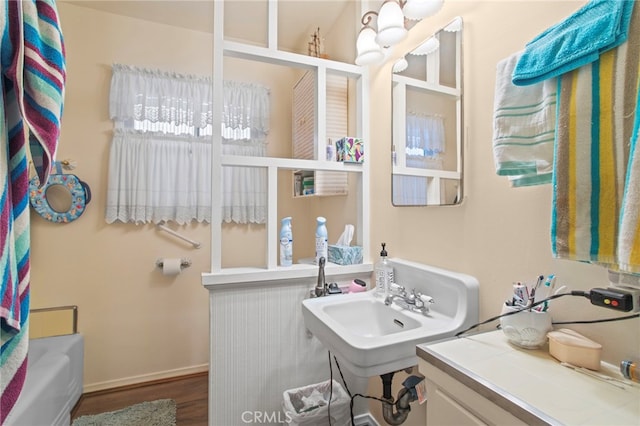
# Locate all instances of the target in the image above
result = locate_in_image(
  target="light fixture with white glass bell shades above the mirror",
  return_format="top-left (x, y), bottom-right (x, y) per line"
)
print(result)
top-left (356, 0), bottom-right (444, 66)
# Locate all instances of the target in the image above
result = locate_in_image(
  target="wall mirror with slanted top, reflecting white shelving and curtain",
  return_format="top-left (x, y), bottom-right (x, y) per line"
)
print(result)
top-left (391, 17), bottom-right (463, 206)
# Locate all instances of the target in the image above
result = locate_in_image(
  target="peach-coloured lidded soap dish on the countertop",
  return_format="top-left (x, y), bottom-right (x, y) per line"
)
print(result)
top-left (547, 328), bottom-right (602, 370)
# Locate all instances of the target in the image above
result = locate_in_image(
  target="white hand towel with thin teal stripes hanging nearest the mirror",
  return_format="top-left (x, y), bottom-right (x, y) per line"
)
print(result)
top-left (493, 52), bottom-right (556, 186)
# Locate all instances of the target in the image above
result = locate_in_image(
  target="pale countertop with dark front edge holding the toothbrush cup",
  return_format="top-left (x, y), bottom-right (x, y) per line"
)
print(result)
top-left (417, 331), bottom-right (640, 426)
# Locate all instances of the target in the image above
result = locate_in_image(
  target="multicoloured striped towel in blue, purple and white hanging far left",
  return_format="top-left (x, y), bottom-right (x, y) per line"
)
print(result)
top-left (0, 0), bottom-right (66, 424)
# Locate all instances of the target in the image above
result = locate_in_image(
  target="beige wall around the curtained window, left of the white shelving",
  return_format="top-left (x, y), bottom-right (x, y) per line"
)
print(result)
top-left (31, 3), bottom-right (212, 390)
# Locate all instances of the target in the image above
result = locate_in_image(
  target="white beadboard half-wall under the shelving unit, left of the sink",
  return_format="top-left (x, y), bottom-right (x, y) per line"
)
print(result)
top-left (209, 279), bottom-right (366, 426)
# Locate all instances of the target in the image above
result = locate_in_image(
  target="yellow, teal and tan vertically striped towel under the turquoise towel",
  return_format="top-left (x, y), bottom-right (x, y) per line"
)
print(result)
top-left (551, 2), bottom-right (640, 272)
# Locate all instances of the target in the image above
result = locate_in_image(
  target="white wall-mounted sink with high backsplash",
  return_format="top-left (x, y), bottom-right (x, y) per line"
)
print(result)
top-left (302, 260), bottom-right (478, 377)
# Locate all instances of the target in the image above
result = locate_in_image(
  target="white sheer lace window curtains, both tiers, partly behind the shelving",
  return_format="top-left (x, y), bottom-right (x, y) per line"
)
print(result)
top-left (106, 65), bottom-right (270, 224)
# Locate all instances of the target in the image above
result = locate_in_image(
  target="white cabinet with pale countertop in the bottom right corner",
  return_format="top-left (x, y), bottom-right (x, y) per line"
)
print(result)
top-left (417, 330), bottom-right (640, 426)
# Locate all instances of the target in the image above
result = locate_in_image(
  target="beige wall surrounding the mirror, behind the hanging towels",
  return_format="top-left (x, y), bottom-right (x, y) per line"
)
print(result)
top-left (371, 1), bottom-right (640, 362)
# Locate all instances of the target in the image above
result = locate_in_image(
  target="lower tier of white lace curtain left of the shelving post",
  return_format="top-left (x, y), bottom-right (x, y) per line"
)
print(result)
top-left (107, 130), bottom-right (211, 223)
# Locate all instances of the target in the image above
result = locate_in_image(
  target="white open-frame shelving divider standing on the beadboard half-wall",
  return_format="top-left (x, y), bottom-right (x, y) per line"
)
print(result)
top-left (202, 0), bottom-right (373, 287)
